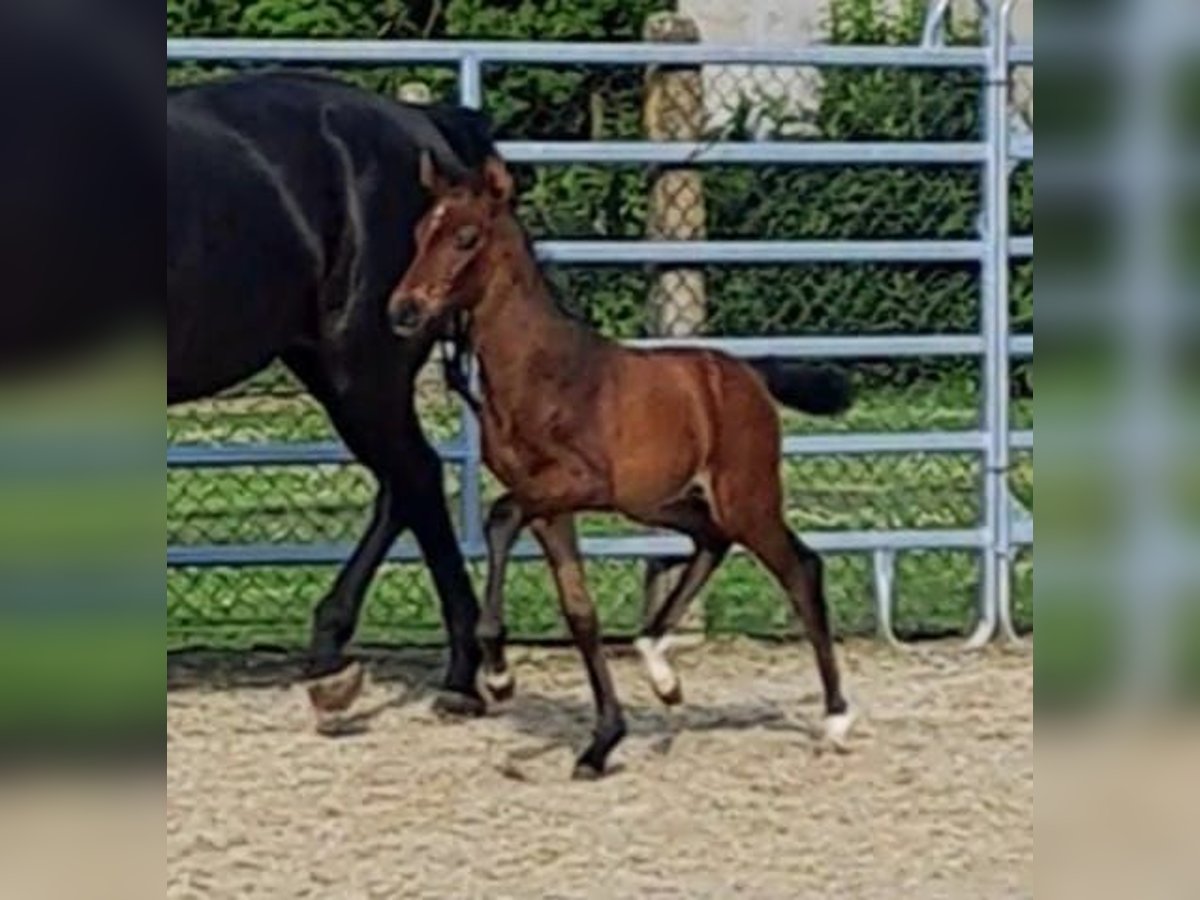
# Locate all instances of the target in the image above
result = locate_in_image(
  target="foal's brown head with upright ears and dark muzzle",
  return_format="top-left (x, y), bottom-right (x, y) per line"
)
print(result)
top-left (388, 154), bottom-right (512, 336)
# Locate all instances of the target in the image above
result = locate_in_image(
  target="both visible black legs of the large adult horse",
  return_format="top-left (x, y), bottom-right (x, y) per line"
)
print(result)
top-left (284, 352), bottom-right (484, 714)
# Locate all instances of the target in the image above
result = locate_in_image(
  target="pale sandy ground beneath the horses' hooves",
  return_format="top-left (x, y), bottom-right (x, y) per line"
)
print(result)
top-left (167, 641), bottom-right (1033, 900)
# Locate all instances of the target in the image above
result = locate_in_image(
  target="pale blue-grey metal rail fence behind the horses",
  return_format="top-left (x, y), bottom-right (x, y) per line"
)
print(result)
top-left (167, 0), bottom-right (1033, 644)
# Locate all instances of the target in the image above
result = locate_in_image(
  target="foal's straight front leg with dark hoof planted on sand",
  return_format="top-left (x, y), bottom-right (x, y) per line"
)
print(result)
top-left (533, 515), bottom-right (625, 779)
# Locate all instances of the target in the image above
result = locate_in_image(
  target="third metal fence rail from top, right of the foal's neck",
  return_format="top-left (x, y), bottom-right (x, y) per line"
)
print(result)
top-left (536, 240), bottom-right (984, 265)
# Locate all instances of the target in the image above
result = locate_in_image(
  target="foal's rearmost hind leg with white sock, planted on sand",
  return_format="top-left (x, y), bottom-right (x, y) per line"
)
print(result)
top-left (740, 518), bottom-right (853, 745)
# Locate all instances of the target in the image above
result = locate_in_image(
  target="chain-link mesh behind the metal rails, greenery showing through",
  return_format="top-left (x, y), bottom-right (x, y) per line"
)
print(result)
top-left (167, 14), bottom-right (1032, 644)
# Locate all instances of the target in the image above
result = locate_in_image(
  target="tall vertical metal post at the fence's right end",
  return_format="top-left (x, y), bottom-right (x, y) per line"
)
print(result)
top-left (967, 0), bottom-right (1013, 647)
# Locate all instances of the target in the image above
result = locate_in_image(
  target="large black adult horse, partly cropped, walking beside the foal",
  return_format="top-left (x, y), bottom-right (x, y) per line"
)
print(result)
top-left (167, 73), bottom-right (494, 712)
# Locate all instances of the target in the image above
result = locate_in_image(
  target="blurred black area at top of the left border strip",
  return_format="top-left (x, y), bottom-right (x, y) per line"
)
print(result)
top-left (0, 0), bottom-right (159, 378)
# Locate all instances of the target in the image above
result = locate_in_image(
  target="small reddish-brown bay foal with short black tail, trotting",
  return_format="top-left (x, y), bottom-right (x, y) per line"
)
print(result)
top-left (389, 156), bottom-right (852, 778)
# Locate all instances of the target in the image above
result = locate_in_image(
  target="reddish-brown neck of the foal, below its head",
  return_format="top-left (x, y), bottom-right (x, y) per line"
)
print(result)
top-left (470, 215), bottom-right (604, 404)
